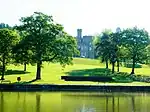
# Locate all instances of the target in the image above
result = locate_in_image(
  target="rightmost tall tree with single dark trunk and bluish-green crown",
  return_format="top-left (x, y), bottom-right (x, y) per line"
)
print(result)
top-left (123, 27), bottom-right (149, 74)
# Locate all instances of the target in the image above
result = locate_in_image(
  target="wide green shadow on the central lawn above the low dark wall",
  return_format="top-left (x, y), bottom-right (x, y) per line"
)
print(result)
top-left (66, 68), bottom-right (111, 76)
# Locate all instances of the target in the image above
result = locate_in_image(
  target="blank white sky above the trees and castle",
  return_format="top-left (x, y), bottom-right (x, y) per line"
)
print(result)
top-left (0, 0), bottom-right (150, 36)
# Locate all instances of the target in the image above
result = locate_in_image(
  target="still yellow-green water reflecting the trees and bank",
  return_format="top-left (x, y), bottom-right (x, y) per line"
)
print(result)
top-left (0, 92), bottom-right (150, 112)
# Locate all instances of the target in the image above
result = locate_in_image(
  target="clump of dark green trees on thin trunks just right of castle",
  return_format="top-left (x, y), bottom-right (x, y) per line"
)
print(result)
top-left (94, 30), bottom-right (127, 73)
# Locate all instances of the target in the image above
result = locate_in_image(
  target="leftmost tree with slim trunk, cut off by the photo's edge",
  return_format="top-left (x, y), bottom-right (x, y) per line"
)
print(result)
top-left (0, 29), bottom-right (19, 80)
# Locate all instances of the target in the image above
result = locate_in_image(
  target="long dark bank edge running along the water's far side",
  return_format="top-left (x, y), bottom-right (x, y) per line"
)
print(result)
top-left (0, 84), bottom-right (150, 92)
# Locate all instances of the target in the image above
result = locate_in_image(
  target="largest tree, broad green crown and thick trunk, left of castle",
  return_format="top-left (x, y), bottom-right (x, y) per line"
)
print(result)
top-left (17, 12), bottom-right (78, 79)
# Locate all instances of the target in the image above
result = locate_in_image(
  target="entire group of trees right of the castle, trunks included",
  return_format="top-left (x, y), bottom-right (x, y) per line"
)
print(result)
top-left (95, 27), bottom-right (149, 74)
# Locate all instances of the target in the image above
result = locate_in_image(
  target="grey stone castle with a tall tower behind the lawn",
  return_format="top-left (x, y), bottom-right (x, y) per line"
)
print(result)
top-left (76, 29), bottom-right (95, 59)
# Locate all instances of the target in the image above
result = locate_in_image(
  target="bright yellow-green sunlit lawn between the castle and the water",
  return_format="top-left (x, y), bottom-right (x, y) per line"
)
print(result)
top-left (1, 58), bottom-right (150, 85)
